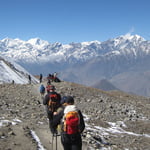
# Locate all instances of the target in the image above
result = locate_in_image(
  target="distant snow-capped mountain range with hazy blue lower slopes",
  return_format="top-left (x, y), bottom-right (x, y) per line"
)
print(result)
top-left (0, 34), bottom-right (150, 96)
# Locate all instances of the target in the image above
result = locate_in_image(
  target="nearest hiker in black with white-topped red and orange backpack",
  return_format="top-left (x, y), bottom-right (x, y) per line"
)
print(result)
top-left (52, 96), bottom-right (85, 150)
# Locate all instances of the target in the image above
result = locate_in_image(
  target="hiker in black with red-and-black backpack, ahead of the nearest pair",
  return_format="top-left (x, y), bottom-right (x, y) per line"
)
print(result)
top-left (43, 85), bottom-right (61, 133)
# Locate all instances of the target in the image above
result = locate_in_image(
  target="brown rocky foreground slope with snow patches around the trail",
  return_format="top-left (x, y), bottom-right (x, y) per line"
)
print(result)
top-left (0, 82), bottom-right (150, 150)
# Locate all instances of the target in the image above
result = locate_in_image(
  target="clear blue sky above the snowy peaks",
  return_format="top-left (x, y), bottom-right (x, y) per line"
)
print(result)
top-left (0, 0), bottom-right (150, 44)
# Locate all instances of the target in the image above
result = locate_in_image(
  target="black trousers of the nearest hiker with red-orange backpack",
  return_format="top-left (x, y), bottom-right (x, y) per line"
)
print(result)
top-left (61, 133), bottom-right (82, 150)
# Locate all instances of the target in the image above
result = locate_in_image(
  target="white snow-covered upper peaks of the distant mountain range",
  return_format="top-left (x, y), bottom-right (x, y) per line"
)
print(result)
top-left (0, 34), bottom-right (150, 63)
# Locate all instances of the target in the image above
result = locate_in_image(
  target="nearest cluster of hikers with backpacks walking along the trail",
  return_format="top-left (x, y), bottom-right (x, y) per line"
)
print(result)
top-left (40, 80), bottom-right (85, 150)
